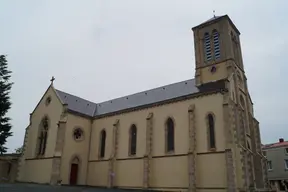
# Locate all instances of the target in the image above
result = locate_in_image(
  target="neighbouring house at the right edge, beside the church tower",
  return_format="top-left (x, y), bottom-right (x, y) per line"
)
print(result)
top-left (262, 138), bottom-right (288, 191)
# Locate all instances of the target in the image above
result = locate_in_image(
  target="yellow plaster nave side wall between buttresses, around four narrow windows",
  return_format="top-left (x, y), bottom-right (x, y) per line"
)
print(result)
top-left (88, 94), bottom-right (226, 187)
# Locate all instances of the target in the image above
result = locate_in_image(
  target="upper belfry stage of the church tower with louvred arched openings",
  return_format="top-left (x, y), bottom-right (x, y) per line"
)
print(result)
top-left (192, 15), bottom-right (244, 86)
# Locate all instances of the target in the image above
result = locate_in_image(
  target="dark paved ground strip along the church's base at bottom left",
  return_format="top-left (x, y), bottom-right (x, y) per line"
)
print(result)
top-left (0, 183), bottom-right (131, 192)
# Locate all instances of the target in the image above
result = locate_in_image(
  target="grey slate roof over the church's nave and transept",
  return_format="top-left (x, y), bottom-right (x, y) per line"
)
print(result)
top-left (56, 79), bottom-right (199, 117)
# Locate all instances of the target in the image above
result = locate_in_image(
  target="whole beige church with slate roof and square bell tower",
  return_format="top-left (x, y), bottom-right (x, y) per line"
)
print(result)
top-left (17, 15), bottom-right (268, 192)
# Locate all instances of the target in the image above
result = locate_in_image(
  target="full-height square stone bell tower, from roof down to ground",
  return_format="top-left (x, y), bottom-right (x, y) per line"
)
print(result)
top-left (192, 15), bottom-right (268, 191)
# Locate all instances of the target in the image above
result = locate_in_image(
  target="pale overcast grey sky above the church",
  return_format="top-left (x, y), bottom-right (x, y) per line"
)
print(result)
top-left (0, 0), bottom-right (288, 151)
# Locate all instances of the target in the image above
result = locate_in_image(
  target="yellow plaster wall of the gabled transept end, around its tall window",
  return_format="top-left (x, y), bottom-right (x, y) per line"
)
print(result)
top-left (19, 87), bottom-right (62, 183)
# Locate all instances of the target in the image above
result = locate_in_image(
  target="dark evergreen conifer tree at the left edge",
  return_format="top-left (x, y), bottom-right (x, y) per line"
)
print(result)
top-left (0, 55), bottom-right (13, 154)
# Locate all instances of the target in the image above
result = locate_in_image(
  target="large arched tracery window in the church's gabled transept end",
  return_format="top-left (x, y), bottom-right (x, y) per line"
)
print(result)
top-left (37, 117), bottom-right (49, 155)
